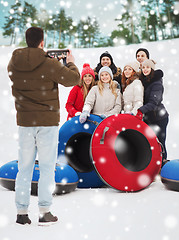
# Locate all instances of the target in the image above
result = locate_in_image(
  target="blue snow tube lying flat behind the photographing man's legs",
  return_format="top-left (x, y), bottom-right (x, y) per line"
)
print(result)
top-left (0, 160), bottom-right (79, 195)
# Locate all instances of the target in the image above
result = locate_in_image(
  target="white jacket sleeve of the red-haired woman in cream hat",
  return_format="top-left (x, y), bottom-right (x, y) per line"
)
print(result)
top-left (131, 80), bottom-right (144, 115)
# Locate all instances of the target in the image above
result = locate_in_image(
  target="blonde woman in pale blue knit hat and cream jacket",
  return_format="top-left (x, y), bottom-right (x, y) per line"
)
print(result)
top-left (79, 66), bottom-right (122, 123)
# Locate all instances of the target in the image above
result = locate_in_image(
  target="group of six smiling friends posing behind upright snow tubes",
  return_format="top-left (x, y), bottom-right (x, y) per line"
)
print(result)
top-left (66, 48), bottom-right (169, 166)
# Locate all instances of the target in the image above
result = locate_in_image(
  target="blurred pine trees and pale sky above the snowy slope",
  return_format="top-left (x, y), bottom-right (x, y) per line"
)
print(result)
top-left (0, 0), bottom-right (179, 48)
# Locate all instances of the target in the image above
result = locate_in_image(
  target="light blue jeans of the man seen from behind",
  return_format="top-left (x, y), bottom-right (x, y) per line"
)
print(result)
top-left (15, 126), bottom-right (58, 214)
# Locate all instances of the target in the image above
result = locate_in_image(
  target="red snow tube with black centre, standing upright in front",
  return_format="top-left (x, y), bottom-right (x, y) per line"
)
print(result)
top-left (90, 114), bottom-right (162, 191)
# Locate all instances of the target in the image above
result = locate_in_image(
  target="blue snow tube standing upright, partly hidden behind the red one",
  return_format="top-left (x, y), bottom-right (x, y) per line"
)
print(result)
top-left (58, 114), bottom-right (104, 188)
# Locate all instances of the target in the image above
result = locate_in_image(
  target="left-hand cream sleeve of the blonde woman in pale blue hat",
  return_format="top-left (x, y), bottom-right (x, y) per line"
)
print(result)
top-left (83, 86), bottom-right (96, 113)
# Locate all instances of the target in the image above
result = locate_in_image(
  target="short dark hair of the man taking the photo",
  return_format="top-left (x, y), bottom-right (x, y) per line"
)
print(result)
top-left (25, 27), bottom-right (44, 48)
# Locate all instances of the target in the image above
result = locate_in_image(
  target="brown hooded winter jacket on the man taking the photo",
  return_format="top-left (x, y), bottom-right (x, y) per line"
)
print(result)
top-left (8, 47), bottom-right (80, 127)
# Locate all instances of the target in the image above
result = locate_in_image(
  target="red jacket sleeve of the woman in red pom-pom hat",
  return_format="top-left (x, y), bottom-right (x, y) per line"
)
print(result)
top-left (65, 87), bottom-right (78, 116)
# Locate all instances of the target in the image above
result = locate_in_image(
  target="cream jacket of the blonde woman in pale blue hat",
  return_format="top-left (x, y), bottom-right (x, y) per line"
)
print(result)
top-left (83, 83), bottom-right (122, 116)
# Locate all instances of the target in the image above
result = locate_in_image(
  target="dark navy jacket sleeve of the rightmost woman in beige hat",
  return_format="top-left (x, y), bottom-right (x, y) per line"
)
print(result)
top-left (140, 82), bottom-right (163, 114)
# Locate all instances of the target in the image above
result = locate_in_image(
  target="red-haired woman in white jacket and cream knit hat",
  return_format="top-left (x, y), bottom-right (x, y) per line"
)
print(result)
top-left (122, 62), bottom-right (144, 115)
